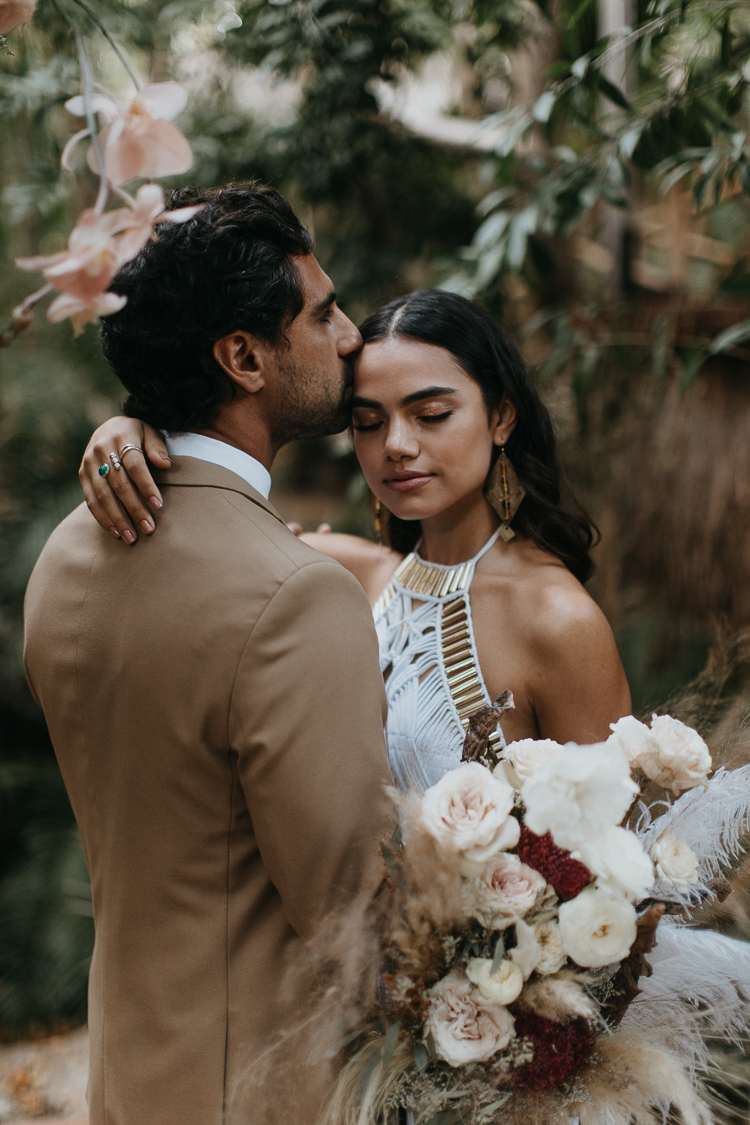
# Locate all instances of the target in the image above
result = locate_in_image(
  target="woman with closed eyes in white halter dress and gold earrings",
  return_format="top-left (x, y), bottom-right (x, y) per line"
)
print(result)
top-left (81, 290), bottom-right (630, 790)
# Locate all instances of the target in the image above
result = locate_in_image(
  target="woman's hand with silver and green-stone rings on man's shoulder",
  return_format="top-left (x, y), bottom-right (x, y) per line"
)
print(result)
top-left (79, 417), bottom-right (172, 545)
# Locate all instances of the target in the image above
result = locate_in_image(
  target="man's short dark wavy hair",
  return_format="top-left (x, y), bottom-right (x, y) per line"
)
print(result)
top-left (100, 185), bottom-right (313, 432)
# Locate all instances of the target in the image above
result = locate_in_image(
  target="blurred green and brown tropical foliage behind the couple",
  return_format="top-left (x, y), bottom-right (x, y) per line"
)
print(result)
top-left (0, 0), bottom-right (750, 1035)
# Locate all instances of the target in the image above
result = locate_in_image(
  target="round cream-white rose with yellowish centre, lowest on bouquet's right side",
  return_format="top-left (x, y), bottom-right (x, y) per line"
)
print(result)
top-left (560, 888), bottom-right (635, 969)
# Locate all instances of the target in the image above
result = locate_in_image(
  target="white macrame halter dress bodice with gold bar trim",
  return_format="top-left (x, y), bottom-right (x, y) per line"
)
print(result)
top-left (372, 531), bottom-right (505, 792)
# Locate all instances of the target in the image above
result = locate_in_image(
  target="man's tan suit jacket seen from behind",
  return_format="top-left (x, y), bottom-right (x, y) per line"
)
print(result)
top-left (26, 457), bottom-right (391, 1125)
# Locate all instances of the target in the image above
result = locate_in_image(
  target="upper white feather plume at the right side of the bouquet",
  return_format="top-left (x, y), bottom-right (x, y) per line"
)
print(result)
top-left (635, 765), bottom-right (750, 901)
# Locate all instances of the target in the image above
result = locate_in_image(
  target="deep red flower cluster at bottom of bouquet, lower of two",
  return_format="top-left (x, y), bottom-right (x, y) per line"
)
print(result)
top-left (514, 1011), bottom-right (596, 1090)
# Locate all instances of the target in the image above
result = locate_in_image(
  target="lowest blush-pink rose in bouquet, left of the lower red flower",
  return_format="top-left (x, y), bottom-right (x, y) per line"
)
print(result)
top-left (425, 969), bottom-right (513, 1067)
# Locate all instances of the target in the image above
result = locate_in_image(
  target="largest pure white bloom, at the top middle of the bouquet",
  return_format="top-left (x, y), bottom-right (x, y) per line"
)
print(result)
top-left (521, 743), bottom-right (638, 852)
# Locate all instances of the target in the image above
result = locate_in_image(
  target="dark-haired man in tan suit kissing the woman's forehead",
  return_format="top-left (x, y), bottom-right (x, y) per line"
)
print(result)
top-left (26, 187), bottom-right (390, 1125)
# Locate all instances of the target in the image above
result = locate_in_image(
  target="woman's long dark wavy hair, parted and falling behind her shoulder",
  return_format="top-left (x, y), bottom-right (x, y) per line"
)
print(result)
top-left (360, 289), bottom-right (598, 582)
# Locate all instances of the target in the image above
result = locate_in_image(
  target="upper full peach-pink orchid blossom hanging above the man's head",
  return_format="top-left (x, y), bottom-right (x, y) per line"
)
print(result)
top-left (63, 82), bottom-right (192, 188)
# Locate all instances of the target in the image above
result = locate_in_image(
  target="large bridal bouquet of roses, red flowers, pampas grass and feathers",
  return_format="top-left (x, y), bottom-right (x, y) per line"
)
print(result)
top-left (325, 699), bottom-right (750, 1125)
